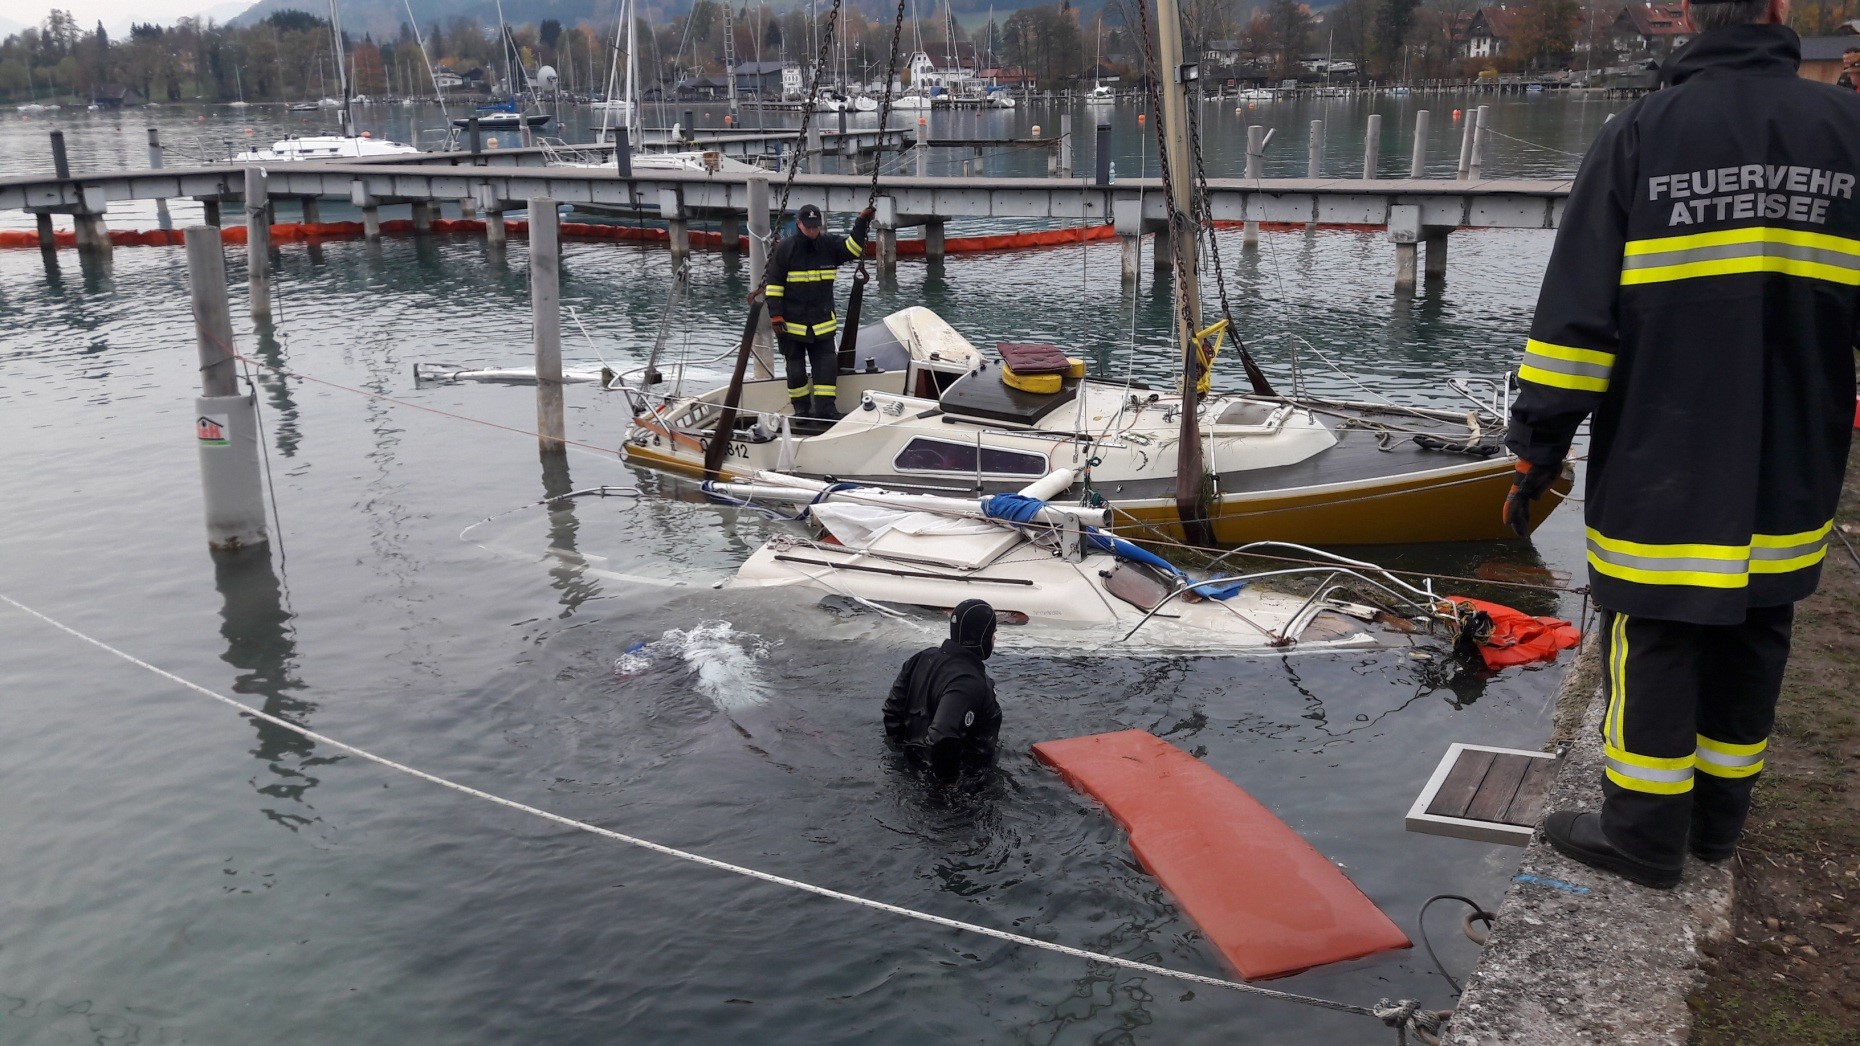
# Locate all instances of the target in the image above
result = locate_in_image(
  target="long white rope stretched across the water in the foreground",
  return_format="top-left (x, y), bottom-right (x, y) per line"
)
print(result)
top-left (0, 592), bottom-right (1440, 1040)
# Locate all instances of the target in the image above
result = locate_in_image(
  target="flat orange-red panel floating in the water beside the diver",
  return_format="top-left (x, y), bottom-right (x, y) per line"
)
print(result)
top-left (1034, 730), bottom-right (1410, 981)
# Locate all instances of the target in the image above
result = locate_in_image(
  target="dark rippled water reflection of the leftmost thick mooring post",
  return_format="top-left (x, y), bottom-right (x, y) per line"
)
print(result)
top-left (212, 547), bottom-right (329, 832)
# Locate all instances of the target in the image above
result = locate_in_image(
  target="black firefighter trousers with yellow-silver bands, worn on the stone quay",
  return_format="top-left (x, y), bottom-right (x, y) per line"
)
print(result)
top-left (1601, 603), bottom-right (1795, 867)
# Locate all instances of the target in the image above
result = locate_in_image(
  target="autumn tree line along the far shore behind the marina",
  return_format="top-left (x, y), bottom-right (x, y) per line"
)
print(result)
top-left (0, 0), bottom-right (1860, 102)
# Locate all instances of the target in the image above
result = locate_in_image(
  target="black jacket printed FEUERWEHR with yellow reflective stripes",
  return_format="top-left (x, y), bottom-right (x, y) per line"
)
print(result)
top-left (1507, 26), bottom-right (1860, 624)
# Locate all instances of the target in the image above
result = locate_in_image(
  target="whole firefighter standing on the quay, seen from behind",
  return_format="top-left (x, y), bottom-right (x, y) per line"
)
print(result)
top-left (1507, 22), bottom-right (1860, 886)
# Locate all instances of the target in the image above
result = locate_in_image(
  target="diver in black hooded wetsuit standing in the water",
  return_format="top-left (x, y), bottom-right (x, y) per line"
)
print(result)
top-left (885, 599), bottom-right (1001, 785)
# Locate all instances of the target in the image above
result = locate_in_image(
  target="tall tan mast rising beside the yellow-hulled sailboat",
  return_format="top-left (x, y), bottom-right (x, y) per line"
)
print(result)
top-left (1149, 0), bottom-right (1209, 543)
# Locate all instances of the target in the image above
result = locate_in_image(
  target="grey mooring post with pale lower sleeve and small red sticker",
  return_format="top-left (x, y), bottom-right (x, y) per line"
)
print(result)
top-left (184, 225), bottom-right (270, 551)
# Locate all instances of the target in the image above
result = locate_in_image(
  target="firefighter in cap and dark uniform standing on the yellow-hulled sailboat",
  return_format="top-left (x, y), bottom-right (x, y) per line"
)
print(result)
top-left (764, 203), bottom-right (872, 419)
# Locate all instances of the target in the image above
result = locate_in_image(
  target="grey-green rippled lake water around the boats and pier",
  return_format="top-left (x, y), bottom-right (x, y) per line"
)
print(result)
top-left (0, 97), bottom-right (1618, 1042)
